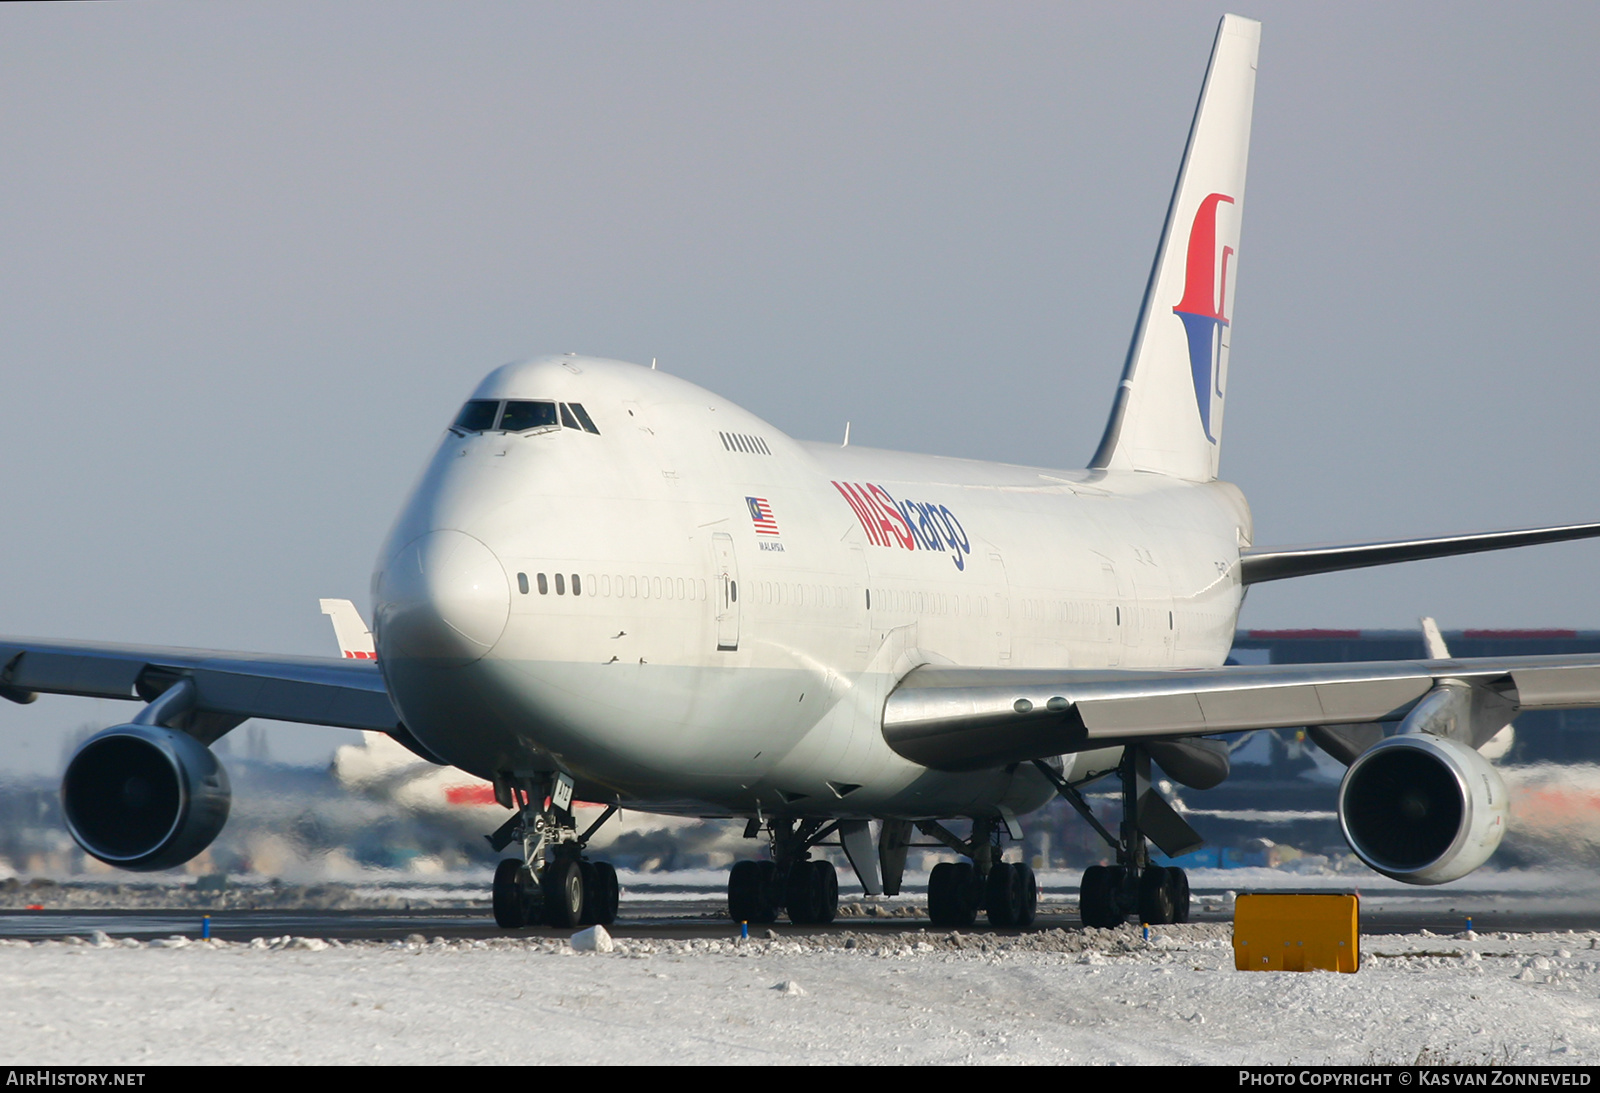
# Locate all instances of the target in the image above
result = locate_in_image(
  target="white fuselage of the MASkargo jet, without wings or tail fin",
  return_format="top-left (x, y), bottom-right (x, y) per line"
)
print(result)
top-left (373, 355), bottom-right (1251, 816)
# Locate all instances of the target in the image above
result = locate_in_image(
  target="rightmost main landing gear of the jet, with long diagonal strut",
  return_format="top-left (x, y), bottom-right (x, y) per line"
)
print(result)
top-left (1034, 746), bottom-right (1203, 928)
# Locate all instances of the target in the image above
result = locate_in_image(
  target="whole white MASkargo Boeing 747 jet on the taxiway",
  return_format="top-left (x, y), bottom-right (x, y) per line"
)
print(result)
top-left (9, 16), bottom-right (1600, 927)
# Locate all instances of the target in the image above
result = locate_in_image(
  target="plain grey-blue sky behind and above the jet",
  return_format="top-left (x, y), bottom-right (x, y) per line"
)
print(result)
top-left (0, 0), bottom-right (1600, 770)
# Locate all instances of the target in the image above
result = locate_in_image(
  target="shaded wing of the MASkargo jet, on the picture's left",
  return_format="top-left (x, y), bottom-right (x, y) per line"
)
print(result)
top-left (0, 637), bottom-right (400, 743)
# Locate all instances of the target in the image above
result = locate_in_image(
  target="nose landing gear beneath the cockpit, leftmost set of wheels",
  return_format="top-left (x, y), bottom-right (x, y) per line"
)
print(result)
top-left (488, 775), bottom-right (618, 930)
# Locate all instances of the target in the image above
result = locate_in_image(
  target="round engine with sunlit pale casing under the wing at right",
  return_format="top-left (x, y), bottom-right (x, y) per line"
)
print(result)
top-left (1339, 733), bottom-right (1507, 885)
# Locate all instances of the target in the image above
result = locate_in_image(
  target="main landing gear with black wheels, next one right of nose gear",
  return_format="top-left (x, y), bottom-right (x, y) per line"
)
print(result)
top-left (728, 819), bottom-right (838, 927)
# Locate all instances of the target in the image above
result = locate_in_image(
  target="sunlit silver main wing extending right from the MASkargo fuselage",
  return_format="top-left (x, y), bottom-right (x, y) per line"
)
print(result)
top-left (883, 653), bottom-right (1600, 770)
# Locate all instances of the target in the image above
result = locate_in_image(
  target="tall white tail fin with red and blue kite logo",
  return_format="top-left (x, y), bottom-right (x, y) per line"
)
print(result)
top-left (1090, 14), bottom-right (1261, 482)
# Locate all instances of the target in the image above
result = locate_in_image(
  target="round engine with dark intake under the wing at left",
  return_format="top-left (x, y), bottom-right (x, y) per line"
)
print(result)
top-left (61, 725), bottom-right (234, 871)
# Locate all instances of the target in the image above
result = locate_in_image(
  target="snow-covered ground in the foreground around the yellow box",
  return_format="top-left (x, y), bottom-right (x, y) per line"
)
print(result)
top-left (0, 923), bottom-right (1600, 1066)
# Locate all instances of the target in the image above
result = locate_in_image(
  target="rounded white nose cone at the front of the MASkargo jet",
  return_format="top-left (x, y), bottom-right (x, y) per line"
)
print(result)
top-left (376, 530), bottom-right (510, 664)
